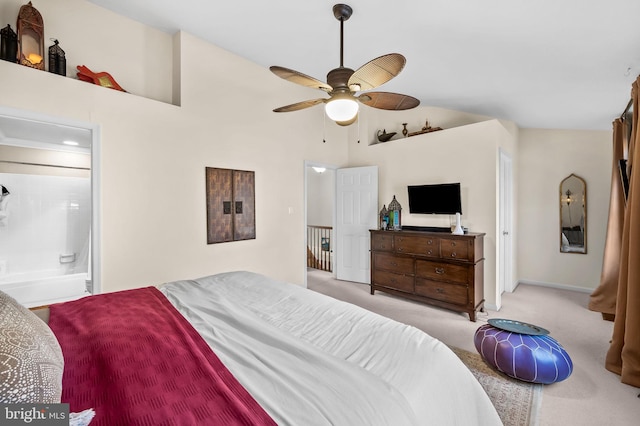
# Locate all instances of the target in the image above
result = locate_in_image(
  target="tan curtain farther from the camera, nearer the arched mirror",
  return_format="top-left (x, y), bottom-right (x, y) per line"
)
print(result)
top-left (589, 118), bottom-right (626, 317)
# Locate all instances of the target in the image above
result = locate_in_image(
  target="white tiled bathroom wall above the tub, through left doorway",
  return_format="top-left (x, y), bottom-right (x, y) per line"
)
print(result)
top-left (0, 173), bottom-right (91, 283)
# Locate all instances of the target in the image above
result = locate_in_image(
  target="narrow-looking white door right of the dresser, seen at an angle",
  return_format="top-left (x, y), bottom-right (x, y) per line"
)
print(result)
top-left (497, 150), bottom-right (513, 294)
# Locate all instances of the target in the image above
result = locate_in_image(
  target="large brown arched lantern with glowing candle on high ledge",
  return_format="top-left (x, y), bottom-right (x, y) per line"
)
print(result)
top-left (17, 2), bottom-right (44, 70)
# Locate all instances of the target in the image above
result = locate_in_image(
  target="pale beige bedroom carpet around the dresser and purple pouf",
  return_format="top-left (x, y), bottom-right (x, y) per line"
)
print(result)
top-left (307, 269), bottom-right (640, 426)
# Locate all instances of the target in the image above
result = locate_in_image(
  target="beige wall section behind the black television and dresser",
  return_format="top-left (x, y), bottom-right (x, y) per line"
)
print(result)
top-left (349, 115), bottom-right (515, 309)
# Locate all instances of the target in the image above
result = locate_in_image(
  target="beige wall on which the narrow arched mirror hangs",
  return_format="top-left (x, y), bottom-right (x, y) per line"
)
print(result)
top-left (517, 129), bottom-right (612, 291)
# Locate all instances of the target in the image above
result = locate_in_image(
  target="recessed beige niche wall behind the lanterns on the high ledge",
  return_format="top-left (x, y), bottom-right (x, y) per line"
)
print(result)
top-left (0, 0), bottom-right (173, 103)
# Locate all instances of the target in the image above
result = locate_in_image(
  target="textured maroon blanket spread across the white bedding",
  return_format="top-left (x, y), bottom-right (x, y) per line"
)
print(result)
top-left (49, 287), bottom-right (275, 426)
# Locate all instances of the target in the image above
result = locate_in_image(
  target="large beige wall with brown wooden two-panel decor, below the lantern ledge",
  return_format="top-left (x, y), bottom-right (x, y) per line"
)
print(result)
top-left (0, 0), bottom-right (347, 291)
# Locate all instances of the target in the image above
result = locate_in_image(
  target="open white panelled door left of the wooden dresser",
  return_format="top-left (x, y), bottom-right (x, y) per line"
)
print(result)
top-left (334, 166), bottom-right (378, 284)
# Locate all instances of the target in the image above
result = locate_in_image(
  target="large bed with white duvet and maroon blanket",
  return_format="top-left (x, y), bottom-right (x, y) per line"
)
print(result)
top-left (0, 271), bottom-right (501, 426)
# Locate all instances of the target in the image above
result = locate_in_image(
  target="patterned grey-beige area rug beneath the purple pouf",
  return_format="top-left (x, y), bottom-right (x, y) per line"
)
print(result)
top-left (450, 346), bottom-right (543, 426)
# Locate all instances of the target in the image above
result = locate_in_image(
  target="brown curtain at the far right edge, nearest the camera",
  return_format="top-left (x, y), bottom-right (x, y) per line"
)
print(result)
top-left (605, 77), bottom-right (640, 387)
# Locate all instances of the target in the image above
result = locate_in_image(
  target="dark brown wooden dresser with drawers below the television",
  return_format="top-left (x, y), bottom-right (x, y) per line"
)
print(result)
top-left (371, 230), bottom-right (485, 321)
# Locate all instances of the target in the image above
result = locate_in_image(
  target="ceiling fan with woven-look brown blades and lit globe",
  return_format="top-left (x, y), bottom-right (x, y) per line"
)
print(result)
top-left (269, 4), bottom-right (420, 126)
